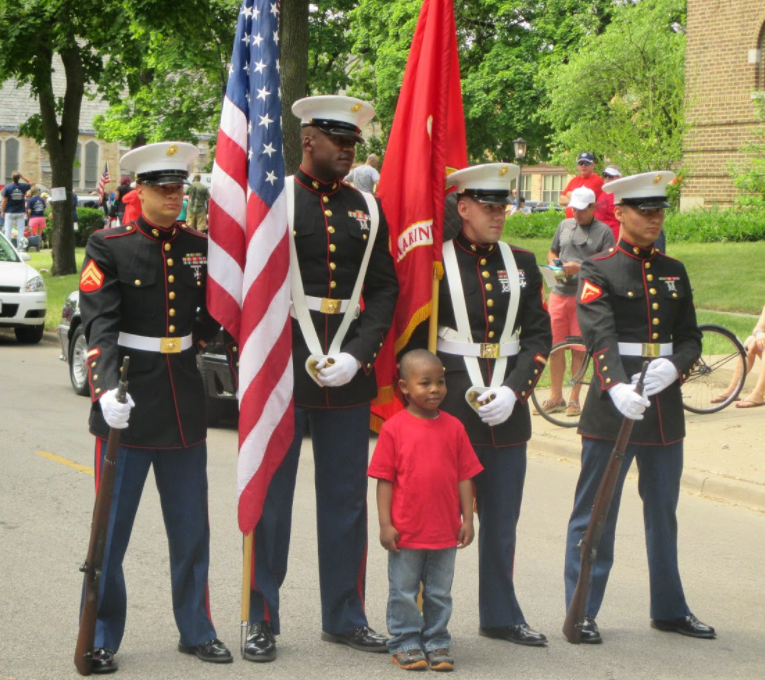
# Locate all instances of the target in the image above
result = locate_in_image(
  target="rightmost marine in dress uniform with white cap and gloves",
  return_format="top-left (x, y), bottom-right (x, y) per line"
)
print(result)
top-left (565, 172), bottom-right (715, 643)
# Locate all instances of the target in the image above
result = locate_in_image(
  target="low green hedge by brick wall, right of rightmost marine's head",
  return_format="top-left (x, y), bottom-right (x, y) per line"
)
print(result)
top-left (664, 207), bottom-right (765, 243)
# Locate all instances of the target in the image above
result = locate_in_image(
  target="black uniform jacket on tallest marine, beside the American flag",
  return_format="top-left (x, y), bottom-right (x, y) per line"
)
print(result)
top-left (292, 168), bottom-right (398, 408)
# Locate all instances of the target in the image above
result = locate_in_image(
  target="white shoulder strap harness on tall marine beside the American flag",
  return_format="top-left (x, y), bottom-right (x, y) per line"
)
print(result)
top-left (284, 175), bottom-right (380, 355)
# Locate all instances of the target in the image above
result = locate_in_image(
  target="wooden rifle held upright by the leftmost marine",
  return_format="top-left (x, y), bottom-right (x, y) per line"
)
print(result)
top-left (74, 357), bottom-right (130, 675)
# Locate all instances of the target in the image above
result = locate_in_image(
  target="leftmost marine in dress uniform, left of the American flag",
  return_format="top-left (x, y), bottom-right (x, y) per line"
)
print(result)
top-left (80, 142), bottom-right (232, 673)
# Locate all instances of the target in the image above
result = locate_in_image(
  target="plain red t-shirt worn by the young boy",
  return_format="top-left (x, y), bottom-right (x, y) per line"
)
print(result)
top-left (368, 411), bottom-right (483, 550)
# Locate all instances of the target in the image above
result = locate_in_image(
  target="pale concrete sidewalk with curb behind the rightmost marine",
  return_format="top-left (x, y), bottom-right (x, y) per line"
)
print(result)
top-left (529, 404), bottom-right (765, 512)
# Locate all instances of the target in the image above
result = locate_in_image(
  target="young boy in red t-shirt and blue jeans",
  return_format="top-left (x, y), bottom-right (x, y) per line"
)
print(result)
top-left (368, 350), bottom-right (483, 671)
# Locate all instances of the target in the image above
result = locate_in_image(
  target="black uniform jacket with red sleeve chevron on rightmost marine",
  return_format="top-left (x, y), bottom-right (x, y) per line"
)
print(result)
top-left (577, 239), bottom-right (701, 444)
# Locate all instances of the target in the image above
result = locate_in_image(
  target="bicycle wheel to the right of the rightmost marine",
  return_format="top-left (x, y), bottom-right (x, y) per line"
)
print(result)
top-left (681, 323), bottom-right (746, 413)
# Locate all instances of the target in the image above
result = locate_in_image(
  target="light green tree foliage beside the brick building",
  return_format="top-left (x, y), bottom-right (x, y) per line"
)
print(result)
top-left (541, 0), bottom-right (686, 175)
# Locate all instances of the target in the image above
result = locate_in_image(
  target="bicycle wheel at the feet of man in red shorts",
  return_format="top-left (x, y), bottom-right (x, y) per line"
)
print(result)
top-left (531, 337), bottom-right (592, 427)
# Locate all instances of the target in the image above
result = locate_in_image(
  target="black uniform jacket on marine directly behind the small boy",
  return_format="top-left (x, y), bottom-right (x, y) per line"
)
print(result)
top-left (430, 233), bottom-right (552, 447)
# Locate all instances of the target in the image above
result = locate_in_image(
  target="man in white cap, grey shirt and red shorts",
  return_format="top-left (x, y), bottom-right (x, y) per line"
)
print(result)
top-left (542, 187), bottom-right (616, 417)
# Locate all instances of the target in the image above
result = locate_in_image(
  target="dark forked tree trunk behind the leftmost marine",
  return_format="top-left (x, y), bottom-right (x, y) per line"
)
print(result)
top-left (36, 46), bottom-right (85, 276)
